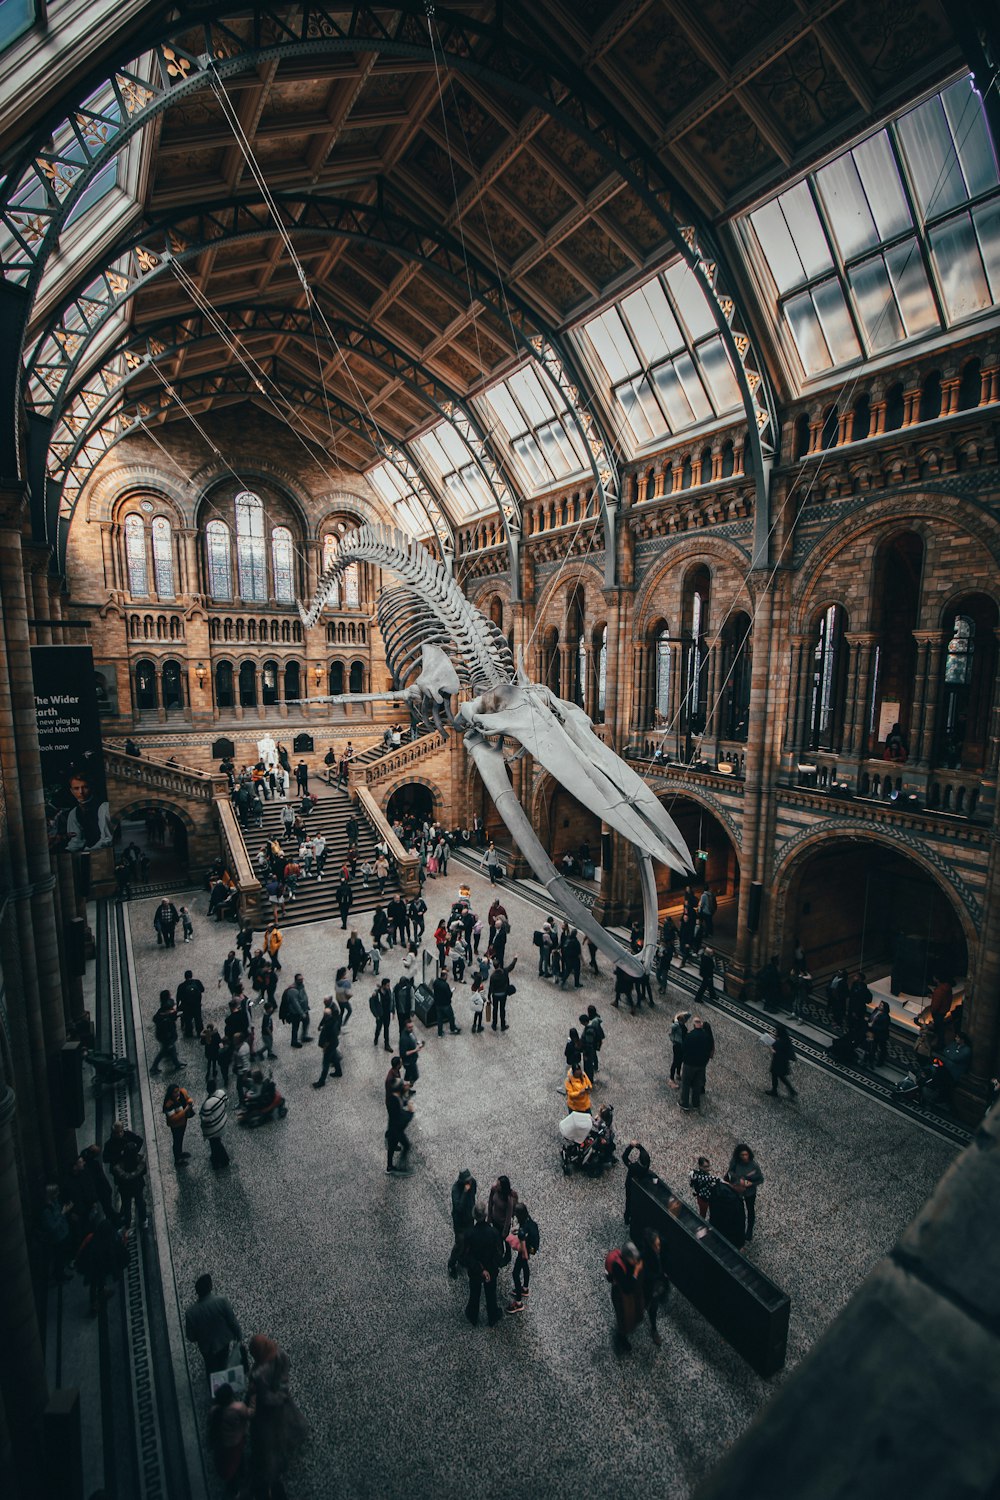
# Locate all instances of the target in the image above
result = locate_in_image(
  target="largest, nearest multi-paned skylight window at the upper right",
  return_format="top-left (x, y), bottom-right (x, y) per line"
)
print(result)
top-left (744, 77), bottom-right (1000, 375)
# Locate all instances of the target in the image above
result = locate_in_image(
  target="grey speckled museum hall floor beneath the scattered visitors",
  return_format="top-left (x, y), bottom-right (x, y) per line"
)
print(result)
top-left (129, 864), bottom-right (954, 1500)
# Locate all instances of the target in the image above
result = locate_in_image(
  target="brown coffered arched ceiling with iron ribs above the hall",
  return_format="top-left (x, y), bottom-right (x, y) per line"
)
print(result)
top-left (4, 0), bottom-right (960, 552)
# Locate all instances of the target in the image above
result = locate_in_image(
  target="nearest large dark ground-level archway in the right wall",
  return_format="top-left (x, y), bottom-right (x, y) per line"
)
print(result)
top-left (780, 839), bottom-right (969, 1019)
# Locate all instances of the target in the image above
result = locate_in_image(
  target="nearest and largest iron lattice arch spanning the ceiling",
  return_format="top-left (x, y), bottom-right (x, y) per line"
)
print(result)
top-left (0, 0), bottom-right (777, 543)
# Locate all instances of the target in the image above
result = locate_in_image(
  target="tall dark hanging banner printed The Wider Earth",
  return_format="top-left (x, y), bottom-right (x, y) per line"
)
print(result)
top-left (31, 647), bottom-right (114, 854)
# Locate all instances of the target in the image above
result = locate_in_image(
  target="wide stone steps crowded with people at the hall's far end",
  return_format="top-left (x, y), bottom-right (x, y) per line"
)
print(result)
top-left (243, 788), bottom-right (400, 938)
